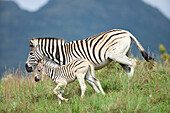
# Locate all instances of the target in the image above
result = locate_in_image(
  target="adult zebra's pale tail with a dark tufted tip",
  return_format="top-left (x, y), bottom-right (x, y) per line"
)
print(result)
top-left (130, 33), bottom-right (155, 62)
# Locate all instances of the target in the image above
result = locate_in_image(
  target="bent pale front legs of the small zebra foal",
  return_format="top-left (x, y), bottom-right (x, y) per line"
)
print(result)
top-left (53, 83), bottom-right (69, 104)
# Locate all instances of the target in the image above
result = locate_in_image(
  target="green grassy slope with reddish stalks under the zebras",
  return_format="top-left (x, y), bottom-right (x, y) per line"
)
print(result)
top-left (0, 61), bottom-right (170, 113)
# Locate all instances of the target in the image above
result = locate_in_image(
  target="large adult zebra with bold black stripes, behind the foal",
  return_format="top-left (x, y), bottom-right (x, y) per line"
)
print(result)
top-left (25, 29), bottom-right (154, 76)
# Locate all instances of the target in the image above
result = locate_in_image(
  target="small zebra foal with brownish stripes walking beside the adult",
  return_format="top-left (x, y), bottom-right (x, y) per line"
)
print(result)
top-left (34, 59), bottom-right (105, 104)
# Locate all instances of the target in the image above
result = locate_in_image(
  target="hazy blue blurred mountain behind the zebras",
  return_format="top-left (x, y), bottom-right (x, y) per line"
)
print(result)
top-left (0, 0), bottom-right (170, 76)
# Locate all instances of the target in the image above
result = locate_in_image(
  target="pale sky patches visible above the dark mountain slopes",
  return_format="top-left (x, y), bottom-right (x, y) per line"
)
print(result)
top-left (2, 0), bottom-right (170, 20)
